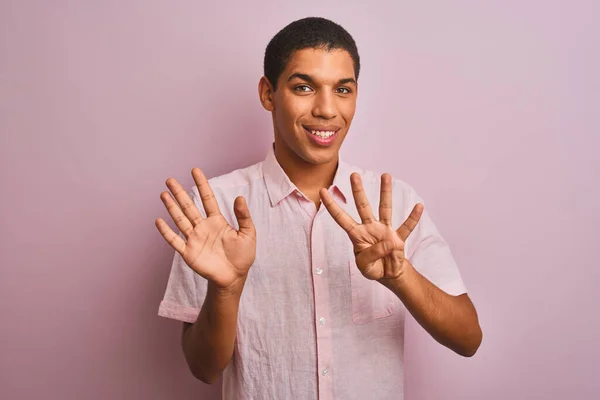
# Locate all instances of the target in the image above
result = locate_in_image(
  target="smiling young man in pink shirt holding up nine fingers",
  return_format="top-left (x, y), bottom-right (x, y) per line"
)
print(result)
top-left (156, 18), bottom-right (482, 400)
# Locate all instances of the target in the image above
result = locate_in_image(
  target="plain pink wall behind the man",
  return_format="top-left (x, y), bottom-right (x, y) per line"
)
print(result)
top-left (0, 0), bottom-right (600, 400)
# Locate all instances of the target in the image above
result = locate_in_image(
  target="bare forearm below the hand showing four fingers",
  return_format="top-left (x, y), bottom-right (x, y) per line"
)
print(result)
top-left (381, 261), bottom-right (482, 357)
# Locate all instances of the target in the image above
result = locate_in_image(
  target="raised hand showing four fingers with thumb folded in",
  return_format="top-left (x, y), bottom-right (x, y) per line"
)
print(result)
top-left (319, 173), bottom-right (423, 280)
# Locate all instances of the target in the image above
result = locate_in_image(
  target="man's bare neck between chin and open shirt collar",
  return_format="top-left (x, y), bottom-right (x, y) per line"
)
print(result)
top-left (275, 140), bottom-right (339, 201)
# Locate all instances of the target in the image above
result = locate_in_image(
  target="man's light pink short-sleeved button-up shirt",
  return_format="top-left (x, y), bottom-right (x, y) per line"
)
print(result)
top-left (159, 148), bottom-right (466, 400)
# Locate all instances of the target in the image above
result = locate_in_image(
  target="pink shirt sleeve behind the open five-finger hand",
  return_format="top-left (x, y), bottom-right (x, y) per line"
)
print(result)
top-left (158, 188), bottom-right (208, 323)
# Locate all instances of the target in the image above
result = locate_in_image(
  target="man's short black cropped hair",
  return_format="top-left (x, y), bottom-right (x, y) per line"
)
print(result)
top-left (263, 17), bottom-right (360, 90)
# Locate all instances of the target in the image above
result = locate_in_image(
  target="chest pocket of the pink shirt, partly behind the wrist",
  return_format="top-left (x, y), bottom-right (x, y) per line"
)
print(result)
top-left (348, 257), bottom-right (396, 325)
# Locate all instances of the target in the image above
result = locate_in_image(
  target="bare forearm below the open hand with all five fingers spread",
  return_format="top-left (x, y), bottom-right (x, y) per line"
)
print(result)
top-left (182, 276), bottom-right (243, 383)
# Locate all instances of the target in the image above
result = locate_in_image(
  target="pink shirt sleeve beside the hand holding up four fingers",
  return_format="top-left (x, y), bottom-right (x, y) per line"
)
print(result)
top-left (400, 188), bottom-right (467, 296)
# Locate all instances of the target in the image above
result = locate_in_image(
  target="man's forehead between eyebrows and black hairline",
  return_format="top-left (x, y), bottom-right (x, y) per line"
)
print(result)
top-left (282, 48), bottom-right (356, 81)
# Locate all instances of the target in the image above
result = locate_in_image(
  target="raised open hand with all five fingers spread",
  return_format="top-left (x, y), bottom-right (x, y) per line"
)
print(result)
top-left (156, 168), bottom-right (256, 289)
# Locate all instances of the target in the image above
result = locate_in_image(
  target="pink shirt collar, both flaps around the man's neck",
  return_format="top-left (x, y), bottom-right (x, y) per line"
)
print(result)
top-left (263, 145), bottom-right (352, 207)
